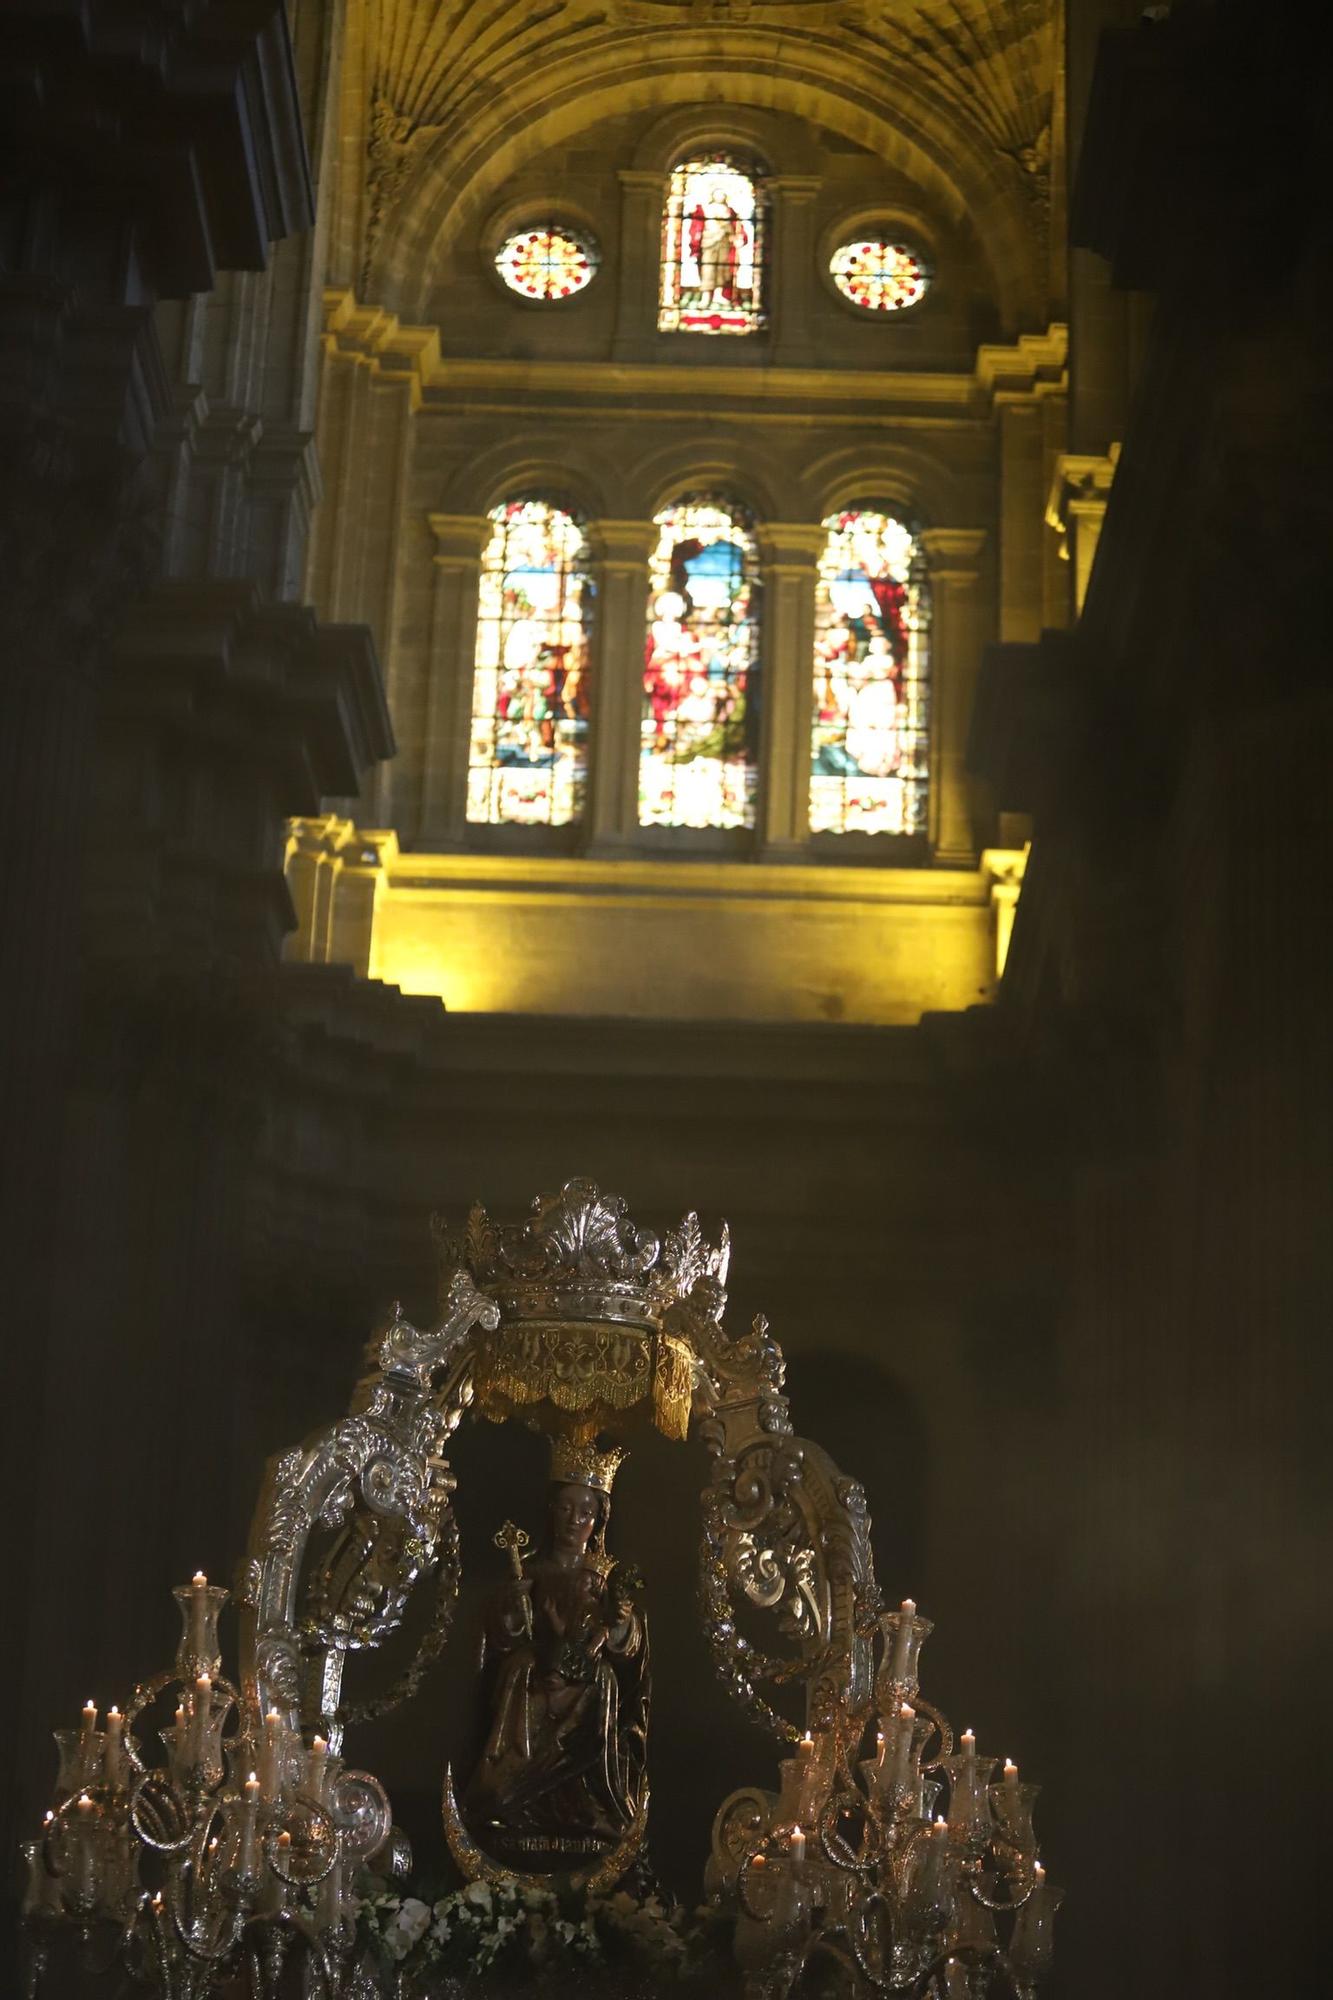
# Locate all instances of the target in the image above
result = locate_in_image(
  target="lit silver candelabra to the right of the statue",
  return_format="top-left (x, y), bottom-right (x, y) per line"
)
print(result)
top-left (715, 1598), bottom-right (1061, 2000)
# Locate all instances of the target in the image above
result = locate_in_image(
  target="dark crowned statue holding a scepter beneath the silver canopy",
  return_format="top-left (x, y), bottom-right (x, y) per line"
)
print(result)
top-left (462, 1438), bottom-right (648, 1872)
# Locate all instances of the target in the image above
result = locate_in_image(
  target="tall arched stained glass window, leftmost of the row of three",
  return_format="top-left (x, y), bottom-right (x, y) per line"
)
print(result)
top-left (468, 500), bottom-right (592, 826)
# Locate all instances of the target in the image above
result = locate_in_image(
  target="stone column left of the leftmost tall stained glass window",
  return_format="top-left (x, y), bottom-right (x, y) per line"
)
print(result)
top-left (418, 514), bottom-right (490, 848)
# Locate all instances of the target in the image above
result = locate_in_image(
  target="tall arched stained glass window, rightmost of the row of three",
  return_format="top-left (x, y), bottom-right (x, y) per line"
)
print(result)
top-left (811, 508), bottom-right (931, 834)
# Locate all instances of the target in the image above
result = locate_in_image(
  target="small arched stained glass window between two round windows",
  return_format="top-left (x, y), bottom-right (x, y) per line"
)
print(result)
top-left (656, 152), bottom-right (767, 334)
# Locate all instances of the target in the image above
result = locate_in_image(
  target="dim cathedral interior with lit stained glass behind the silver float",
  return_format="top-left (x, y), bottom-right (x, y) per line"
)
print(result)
top-left (0, 0), bottom-right (1333, 2000)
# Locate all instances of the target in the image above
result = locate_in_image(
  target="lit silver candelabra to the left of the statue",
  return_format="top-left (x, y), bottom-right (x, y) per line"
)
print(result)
top-left (24, 1574), bottom-right (400, 2000)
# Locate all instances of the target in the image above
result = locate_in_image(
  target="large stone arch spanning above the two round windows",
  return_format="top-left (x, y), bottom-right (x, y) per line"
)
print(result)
top-left (382, 32), bottom-right (1045, 328)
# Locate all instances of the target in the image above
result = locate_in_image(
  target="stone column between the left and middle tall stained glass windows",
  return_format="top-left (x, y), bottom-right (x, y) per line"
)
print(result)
top-left (584, 520), bottom-right (656, 854)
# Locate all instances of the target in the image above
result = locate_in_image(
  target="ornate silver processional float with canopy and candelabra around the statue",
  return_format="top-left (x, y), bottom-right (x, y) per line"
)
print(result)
top-left (24, 1180), bottom-right (1059, 2000)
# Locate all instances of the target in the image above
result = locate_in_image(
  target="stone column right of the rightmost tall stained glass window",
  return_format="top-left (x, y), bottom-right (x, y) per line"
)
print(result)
top-left (921, 528), bottom-right (991, 868)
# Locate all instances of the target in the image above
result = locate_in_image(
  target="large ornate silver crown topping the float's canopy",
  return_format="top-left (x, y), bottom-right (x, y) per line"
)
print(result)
top-left (434, 1180), bottom-right (731, 1330)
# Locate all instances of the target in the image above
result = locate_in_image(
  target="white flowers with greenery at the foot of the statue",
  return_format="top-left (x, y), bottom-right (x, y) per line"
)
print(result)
top-left (358, 1876), bottom-right (727, 1996)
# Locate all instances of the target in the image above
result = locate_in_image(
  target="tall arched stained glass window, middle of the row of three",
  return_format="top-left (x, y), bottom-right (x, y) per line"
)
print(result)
top-left (638, 494), bottom-right (759, 826)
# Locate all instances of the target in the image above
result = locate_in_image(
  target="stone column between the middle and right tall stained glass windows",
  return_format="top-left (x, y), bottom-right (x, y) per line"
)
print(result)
top-left (757, 522), bottom-right (825, 860)
